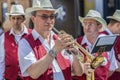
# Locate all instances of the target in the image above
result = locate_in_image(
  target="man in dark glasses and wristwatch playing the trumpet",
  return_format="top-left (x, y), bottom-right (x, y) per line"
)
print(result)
top-left (19, 0), bottom-right (89, 80)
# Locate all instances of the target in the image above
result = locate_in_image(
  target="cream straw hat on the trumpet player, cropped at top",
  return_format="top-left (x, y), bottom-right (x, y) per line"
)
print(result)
top-left (26, 0), bottom-right (57, 13)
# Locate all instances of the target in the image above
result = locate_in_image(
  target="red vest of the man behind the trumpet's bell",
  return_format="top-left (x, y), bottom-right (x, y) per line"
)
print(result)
top-left (73, 37), bottom-right (110, 80)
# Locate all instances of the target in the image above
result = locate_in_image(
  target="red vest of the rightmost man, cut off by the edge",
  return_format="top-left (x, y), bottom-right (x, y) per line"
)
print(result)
top-left (101, 31), bottom-right (120, 80)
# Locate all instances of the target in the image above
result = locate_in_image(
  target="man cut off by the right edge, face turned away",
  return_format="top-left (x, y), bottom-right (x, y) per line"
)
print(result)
top-left (101, 9), bottom-right (120, 80)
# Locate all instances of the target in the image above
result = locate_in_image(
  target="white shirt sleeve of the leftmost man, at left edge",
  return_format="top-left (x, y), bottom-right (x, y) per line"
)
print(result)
top-left (0, 34), bottom-right (5, 80)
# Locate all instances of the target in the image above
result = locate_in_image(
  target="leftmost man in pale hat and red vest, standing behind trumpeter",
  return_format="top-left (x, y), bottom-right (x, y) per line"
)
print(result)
top-left (0, 4), bottom-right (29, 80)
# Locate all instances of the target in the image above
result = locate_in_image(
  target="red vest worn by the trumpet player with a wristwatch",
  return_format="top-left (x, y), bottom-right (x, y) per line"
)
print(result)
top-left (25, 34), bottom-right (72, 80)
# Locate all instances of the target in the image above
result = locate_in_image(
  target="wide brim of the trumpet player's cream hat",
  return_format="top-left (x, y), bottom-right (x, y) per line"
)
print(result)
top-left (25, 7), bottom-right (58, 14)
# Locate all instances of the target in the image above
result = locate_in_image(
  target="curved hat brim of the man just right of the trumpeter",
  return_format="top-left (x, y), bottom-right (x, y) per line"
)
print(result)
top-left (79, 16), bottom-right (107, 29)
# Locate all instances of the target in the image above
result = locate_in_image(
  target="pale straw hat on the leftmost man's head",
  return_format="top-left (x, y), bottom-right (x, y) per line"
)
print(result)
top-left (6, 4), bottom-right (25, 16)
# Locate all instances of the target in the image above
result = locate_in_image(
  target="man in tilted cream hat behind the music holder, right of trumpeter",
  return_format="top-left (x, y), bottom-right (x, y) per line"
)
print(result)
top-left (72, 10), bottom-right (117, 80)
